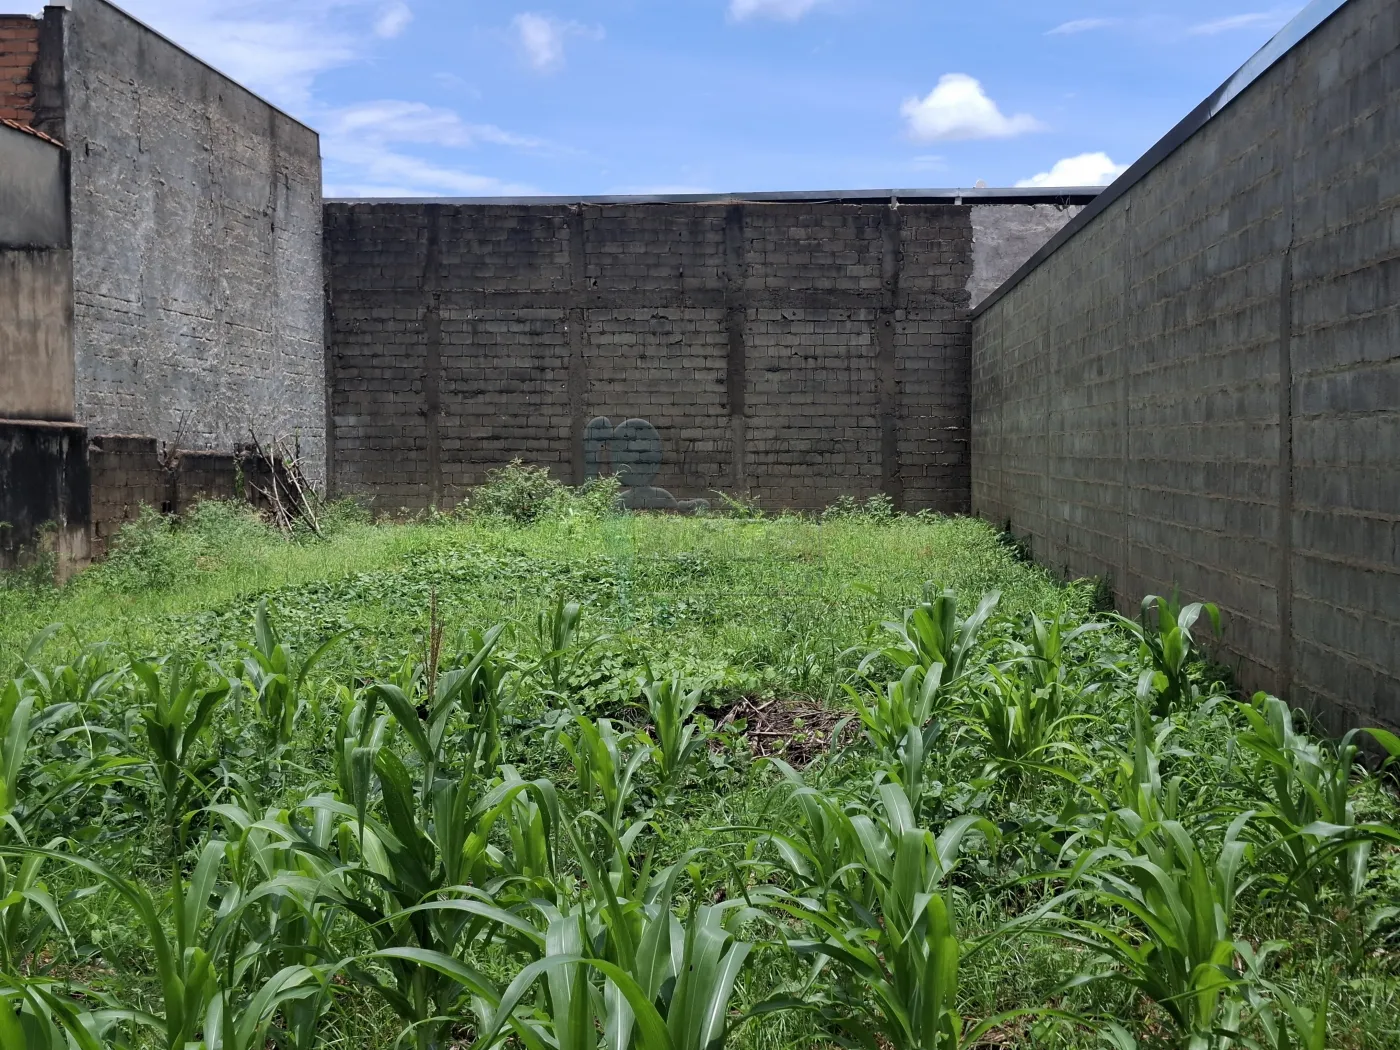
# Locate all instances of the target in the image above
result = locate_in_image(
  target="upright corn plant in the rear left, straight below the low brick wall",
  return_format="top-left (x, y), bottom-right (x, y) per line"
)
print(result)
top-left (132, 657), bottom-right (230, 851)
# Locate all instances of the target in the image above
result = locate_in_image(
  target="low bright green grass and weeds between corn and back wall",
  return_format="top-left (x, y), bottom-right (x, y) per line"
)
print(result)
top-left (0, 504), bottom-right (1069, 694)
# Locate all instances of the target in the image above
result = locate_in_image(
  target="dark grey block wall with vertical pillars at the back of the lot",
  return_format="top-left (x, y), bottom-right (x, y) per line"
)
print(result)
top-left (326, 197), bottom-right (1068, 511)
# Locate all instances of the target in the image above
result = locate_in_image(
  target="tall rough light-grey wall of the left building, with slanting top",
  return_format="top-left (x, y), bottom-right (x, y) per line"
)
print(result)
top-left (36, 0), bottom-right (325, 479)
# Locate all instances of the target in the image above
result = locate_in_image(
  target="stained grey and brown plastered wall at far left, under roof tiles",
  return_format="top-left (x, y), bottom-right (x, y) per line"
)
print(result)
top-left (0, 125), bottom-right (73, 420)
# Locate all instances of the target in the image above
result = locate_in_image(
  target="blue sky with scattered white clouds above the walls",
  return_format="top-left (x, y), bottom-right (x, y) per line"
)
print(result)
top-left (87, 0), bottom-right (1302, 196)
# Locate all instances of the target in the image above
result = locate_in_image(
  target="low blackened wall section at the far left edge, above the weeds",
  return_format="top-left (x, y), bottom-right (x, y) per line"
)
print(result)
top-left (0, 419), bottom-right (90, 575)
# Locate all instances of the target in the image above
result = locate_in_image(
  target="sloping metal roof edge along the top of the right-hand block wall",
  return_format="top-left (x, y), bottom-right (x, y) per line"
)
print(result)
top-left (970, 0), bottom-right (1348, 321)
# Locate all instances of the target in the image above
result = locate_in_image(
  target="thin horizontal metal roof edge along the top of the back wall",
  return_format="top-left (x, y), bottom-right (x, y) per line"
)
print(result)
top-left (325, 186), bottom-right (1102, 207)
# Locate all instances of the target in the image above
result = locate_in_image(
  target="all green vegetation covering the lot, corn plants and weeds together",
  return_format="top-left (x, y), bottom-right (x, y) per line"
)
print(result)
top-left (0, 477), bottom-right (1400, 1050)
